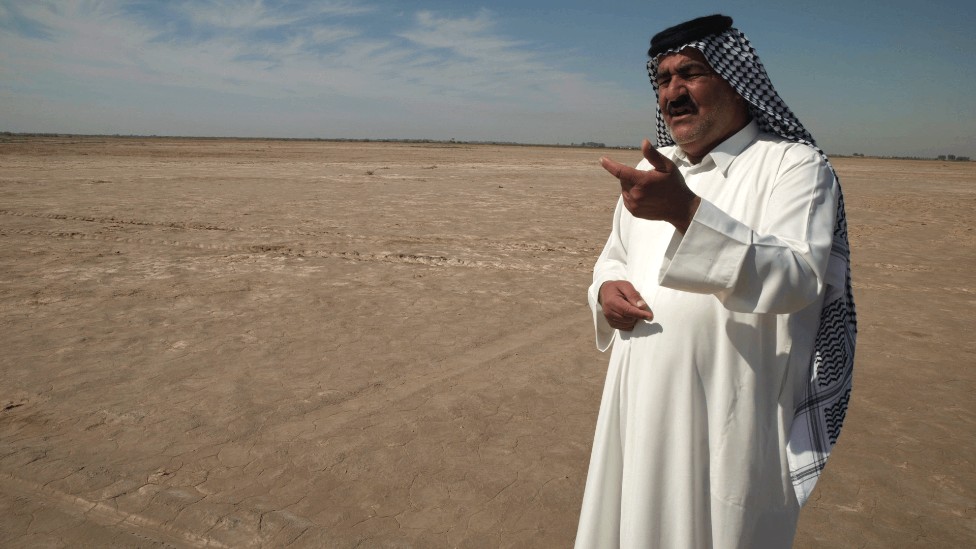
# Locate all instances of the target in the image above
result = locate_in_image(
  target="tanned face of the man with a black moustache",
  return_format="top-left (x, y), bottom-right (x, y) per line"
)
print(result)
top-left (657, 48), bottom-right (749, 161)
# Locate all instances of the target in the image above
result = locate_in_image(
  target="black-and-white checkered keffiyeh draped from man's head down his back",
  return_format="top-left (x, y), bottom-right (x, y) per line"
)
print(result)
top-left (647, 27), bottom-right (857, 505)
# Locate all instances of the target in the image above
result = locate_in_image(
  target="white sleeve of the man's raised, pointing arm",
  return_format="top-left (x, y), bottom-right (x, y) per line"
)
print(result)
top-left (659, 149), bottom-right (837, 314)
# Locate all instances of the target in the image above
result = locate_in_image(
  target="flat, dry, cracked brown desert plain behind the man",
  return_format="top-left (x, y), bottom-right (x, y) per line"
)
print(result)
top-left (0, 136), bottom-right (976, 548)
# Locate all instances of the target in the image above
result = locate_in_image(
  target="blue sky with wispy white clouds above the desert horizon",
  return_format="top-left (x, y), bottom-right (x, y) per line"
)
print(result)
top-left (0, 0), bottom-right (976, 157)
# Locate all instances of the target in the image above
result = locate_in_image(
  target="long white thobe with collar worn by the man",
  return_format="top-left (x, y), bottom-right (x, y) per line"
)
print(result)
top-left (576, 122), bottom-right (843, 549)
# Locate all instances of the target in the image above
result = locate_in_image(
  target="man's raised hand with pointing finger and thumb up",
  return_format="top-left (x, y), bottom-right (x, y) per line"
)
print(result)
top-left (600, 139), bottom-right (701, 234)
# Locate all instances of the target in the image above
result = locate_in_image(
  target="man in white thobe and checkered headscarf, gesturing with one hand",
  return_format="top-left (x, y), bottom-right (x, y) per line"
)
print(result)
top-left (576, 15), bottom-right (856, 549)
